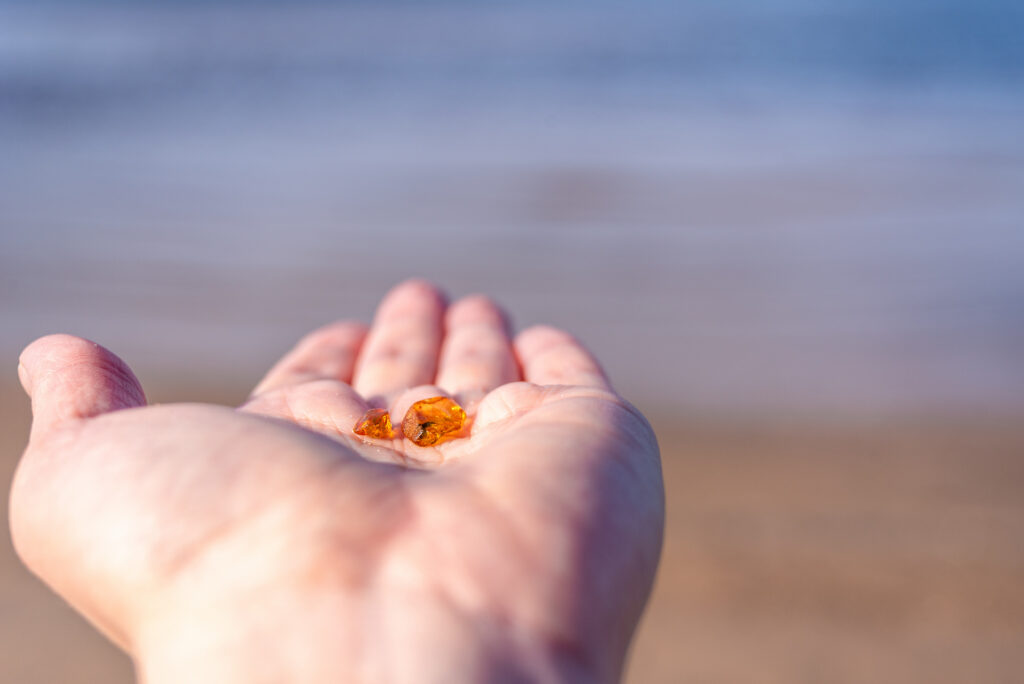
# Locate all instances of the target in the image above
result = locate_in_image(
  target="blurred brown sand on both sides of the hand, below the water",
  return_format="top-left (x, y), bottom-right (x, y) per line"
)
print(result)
top-left (0, 384), bottom-right (1024, 684)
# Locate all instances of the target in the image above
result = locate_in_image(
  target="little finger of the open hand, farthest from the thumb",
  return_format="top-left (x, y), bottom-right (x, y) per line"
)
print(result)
top-left (514, 326), bottom-right (610, 389)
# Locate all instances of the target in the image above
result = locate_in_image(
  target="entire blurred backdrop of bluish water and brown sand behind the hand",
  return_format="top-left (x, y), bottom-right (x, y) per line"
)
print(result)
top-left (0, 0), bottom-right (1024, 684)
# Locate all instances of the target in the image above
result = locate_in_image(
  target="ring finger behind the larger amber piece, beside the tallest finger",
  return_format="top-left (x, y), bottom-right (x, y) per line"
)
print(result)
top-left (437, 296), bottom-right (519, 405)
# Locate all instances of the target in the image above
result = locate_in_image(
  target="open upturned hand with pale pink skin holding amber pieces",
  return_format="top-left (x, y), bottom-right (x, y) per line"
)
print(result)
top-left (10, 281), bottom-right (665, 684)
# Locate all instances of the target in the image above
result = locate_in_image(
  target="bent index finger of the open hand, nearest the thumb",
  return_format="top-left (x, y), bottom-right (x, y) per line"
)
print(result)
top-left (253, 320), bottom-right (367, 395)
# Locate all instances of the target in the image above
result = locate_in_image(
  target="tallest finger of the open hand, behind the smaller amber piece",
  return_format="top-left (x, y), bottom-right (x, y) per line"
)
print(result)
top-left (352, 281), bottom-right (445, 405)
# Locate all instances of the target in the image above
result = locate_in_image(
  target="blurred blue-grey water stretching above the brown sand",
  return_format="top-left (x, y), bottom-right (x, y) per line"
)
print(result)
top-left (0, 0), bottom-right (1024, 411)
